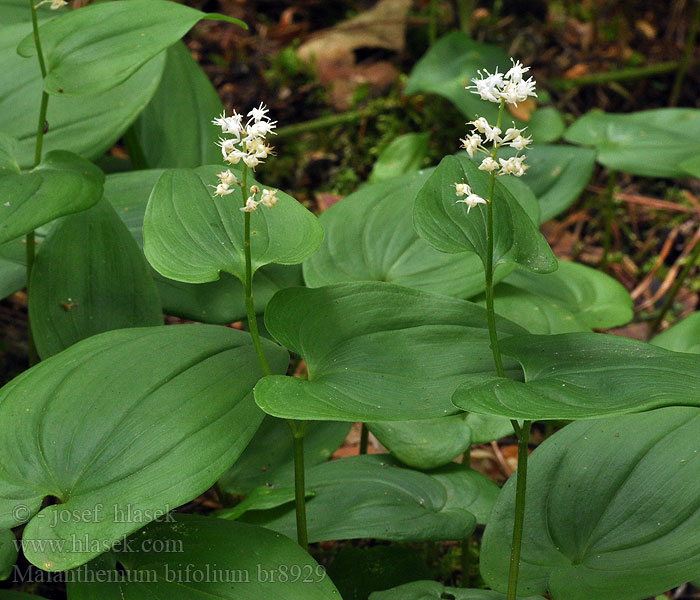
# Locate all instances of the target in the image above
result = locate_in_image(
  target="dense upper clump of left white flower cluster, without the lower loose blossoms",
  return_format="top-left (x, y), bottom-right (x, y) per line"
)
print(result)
top-left (212, 103), bottom-right (277, 169)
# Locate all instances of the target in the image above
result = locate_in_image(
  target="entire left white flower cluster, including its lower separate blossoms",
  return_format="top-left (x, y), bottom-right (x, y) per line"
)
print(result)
top-left (210, 103), bottom-right (277, 212)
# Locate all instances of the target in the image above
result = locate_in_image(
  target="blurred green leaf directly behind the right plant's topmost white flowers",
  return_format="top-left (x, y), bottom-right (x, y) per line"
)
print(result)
top-left (404, 31), bottom-right (564, 143)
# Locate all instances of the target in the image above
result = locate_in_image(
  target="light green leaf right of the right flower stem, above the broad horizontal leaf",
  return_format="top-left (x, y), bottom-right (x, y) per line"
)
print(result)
top-left (476, 260), bottom-right (634, 333)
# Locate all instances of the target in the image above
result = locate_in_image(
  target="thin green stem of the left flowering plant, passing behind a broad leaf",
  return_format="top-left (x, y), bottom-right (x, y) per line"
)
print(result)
top-left (241, 165), bottom-right (309, 550)
